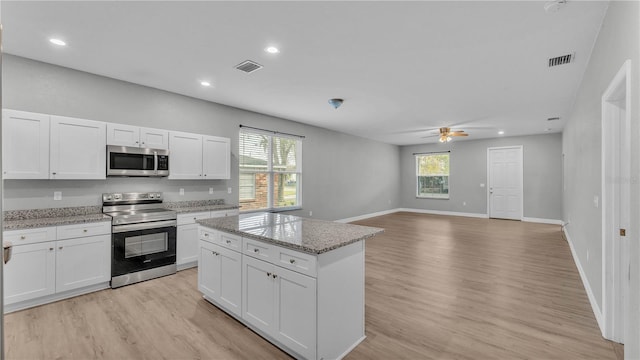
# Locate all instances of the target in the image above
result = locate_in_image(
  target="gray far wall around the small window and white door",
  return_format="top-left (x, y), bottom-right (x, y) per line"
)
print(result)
top-left (400, 133), bottom-right (562, 220)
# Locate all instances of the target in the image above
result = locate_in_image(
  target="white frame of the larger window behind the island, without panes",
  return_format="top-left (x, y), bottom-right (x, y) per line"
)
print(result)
top-left (238, 130), bottom-right (302, 213)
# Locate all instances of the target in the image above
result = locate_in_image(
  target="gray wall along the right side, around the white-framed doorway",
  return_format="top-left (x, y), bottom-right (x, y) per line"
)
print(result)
top-left (563, 1), bottom-right (640, 359)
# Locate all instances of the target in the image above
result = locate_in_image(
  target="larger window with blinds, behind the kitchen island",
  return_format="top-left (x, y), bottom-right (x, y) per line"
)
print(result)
top-left (239, 130), bottom-right (302, 211)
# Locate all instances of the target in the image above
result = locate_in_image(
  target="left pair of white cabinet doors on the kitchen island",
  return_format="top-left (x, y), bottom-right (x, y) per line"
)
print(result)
top-left (198, 240), bottom-right (242, 317)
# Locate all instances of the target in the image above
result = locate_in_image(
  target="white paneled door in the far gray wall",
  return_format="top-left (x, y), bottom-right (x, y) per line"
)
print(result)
top-left (487, 146), bottom-right (523, 220)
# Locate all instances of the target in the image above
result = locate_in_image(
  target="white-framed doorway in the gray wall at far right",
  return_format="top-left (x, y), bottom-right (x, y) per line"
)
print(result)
top-left (600, 60), bottom-right (632, 343)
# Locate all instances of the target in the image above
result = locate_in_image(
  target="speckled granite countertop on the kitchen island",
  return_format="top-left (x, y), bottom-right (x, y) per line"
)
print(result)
top-left (196, 212), bottom-right (384, 254)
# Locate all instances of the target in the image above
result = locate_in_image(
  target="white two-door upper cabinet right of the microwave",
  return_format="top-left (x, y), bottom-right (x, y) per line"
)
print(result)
top-left (169, 131), bottom-right (231, 180)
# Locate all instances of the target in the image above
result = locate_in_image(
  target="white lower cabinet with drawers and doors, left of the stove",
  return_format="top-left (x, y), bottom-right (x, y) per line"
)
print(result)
top-left (3, 222), bottom-right (111, 311)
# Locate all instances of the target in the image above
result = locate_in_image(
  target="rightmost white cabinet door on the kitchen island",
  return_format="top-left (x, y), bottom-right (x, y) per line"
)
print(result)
top-left (275, 267), bottom-right (316, 359)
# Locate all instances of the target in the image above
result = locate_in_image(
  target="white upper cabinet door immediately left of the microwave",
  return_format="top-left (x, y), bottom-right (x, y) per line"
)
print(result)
top-left (50, 116), bottom-right (107, 179)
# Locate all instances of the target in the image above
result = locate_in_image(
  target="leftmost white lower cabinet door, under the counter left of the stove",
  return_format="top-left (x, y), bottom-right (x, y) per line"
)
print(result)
top-left (3, 241), bottom-right (56, 305)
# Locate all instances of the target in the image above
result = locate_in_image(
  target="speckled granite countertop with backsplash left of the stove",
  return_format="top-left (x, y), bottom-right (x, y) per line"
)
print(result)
top-left (2, 206), bottom-right (111, 231)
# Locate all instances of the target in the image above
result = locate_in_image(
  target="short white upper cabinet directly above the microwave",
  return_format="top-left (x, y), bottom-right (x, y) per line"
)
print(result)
top-left (107, 123), bottom-right (169, 149)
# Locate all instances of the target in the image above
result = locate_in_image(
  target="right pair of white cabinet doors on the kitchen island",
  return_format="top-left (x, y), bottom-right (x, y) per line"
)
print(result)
top-left (243, 255), bottom-right (316, 359)
